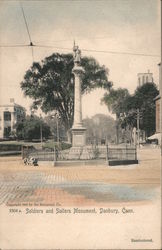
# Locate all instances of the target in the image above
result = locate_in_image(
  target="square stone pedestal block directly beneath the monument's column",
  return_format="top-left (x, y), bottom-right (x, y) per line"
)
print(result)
top-left (71, 127), bottom-right (86, 147)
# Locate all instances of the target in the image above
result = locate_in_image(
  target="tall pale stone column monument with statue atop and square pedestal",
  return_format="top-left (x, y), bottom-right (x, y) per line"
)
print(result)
top-left (71, 43), bottom-right (86, 147)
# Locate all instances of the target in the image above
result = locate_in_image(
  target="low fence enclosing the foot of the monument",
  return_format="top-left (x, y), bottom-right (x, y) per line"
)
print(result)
top-left (22, 145), bottom-right (137, 161)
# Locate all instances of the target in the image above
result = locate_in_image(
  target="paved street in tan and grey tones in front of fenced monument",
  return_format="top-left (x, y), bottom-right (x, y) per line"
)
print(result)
top-left (0, 148), bottom-right (160, 206)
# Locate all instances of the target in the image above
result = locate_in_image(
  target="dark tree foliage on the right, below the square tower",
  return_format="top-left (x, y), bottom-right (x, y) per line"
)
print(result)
top-left (103, 83), bottom-right (158, 140)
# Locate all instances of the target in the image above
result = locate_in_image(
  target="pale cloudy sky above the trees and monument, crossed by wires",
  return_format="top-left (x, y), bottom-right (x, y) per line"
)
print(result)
top-left (0, 0), bottom-right (160, 118)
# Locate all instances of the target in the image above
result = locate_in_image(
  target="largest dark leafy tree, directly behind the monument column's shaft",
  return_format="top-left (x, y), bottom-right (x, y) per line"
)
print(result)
top-left (21, 53), bottom-right (111, 135)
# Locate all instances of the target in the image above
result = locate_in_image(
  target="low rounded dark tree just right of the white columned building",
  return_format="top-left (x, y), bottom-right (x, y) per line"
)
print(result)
top-left (16, 116), bottom-right (50, 140)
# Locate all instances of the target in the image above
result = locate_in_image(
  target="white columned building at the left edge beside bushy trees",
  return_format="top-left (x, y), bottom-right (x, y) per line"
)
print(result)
top-left (0, 99), bottom-right (26, 139)
